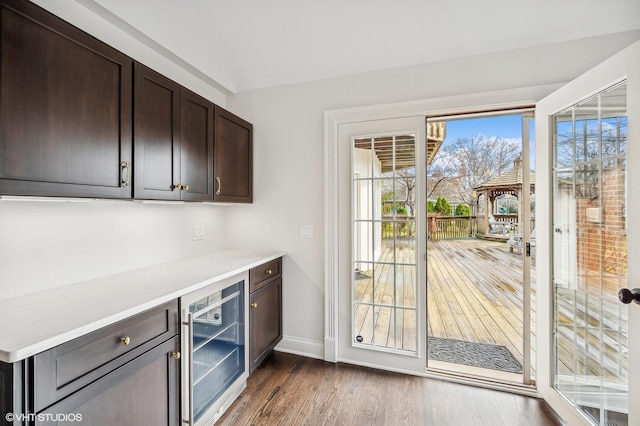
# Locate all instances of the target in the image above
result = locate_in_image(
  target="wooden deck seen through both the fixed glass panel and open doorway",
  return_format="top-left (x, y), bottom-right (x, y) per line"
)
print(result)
top-left (355, 238), bottom-right (535, 362)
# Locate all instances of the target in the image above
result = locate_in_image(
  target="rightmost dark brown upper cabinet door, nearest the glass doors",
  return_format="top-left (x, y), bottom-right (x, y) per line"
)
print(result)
top-left (213, 106), bottom-right (253, 203)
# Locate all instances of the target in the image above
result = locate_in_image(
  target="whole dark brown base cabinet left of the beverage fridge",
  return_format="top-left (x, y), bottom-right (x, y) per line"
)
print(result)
top-left (0, 301), bottom-right (181, 425)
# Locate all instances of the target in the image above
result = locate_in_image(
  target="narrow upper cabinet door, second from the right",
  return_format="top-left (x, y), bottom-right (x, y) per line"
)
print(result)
top-left (180, 88), bottom-right (213, 201)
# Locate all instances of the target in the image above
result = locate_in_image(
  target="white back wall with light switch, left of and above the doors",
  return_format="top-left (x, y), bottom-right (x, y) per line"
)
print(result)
top-left (227, 32), bottom-right (640, 357)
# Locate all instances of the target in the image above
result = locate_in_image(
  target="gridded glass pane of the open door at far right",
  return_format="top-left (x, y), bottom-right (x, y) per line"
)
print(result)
top-left (553, 83), bottom-right (628, 425)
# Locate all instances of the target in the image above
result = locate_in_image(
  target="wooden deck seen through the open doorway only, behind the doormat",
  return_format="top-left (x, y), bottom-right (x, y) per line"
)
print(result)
top-left (427, 238), bottom-right (535, 363)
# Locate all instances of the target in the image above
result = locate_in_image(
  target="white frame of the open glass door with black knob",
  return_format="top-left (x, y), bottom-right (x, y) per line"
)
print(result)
top-left (535, 38), bottom-right (640, 424)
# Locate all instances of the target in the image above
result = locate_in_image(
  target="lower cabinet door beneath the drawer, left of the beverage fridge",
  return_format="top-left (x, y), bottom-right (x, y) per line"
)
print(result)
top-left (35, 336), bottom-right (180, 425)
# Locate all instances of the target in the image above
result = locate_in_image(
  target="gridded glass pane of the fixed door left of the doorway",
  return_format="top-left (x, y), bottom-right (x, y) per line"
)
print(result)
top-left (352, 134), bottom-right (417, 354)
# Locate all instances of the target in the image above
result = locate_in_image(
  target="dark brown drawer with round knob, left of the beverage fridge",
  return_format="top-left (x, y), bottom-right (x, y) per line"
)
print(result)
top-left (34, 300), bottom-right (179, 411)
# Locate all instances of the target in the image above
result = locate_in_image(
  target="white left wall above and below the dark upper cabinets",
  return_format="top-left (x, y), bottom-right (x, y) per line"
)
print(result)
top-left (0, 0), bottom-right (235, 299)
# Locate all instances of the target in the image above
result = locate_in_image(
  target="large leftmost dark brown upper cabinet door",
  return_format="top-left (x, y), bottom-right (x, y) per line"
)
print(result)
top-left (0, 0), bottom-right (132, 198)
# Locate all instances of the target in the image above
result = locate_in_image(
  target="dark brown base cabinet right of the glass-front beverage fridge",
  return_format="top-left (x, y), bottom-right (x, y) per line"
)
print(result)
top-left (249, 258), bottom-right (282, 372)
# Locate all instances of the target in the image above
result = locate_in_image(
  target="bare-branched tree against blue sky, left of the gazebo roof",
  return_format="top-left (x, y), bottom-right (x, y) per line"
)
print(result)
top-left (427, 134), bottom-right (522, 204)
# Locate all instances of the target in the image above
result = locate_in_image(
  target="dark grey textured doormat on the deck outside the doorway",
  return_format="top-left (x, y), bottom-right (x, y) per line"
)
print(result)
top-left (428, 337), bottom-right (522, 373)
